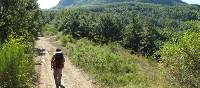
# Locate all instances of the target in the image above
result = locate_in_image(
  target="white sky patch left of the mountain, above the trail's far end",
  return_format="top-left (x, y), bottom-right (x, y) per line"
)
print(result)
top-left (38, 0), bottom-right (60, 9)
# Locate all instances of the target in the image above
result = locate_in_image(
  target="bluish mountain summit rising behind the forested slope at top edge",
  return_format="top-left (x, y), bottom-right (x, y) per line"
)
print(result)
top-left (57, 0), bottom-right (186, 7)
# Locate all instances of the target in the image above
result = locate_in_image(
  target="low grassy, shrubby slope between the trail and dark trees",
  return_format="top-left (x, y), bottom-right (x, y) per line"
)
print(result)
top-left (61, 37), bottom-right (164, 88)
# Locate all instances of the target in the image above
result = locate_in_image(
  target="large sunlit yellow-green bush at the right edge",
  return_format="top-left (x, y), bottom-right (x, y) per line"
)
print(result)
top-left (159, 32), bottom-right (200, 88)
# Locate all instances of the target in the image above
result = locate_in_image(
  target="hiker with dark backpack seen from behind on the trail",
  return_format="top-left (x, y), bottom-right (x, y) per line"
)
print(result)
top-left (51, 49), bottom-right (65, 88)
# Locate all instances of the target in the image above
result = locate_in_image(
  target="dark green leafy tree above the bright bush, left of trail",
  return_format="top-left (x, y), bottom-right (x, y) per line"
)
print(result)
top-left (0, 0), bottom-right (41, 41)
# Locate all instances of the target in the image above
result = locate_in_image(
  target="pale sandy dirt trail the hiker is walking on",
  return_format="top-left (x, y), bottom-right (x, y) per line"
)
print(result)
top-left (36, 37), bottom-right (95, 88)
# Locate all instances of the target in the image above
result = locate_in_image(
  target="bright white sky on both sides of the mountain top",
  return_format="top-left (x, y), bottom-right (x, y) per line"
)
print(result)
top-left (38, 0), bottom-right (200, 9)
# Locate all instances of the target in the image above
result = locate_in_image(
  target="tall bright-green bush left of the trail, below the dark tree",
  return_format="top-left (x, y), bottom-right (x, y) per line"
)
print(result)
top-left (0, 39), bottom-right (34, 88)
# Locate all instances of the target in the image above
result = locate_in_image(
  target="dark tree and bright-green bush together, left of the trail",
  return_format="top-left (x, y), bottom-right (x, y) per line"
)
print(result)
top-left (0, 0), bottom-right (42, 88)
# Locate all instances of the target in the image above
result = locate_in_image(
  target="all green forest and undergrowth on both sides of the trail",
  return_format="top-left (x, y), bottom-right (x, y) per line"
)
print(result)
top-left (0, 0), bottom-right (200, 88)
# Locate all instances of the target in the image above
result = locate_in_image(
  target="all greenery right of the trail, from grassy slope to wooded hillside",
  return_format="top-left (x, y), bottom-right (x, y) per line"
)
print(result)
top-left (43, 3), bottom-right (200, 88)
